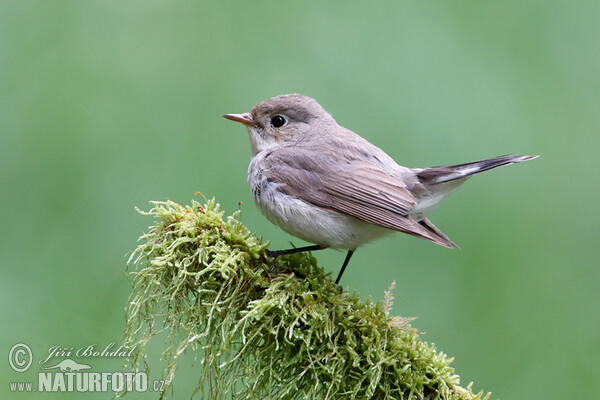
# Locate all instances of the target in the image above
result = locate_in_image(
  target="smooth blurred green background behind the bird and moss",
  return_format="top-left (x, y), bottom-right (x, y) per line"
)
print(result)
top-left (0, 0), bottom-right (600, 399)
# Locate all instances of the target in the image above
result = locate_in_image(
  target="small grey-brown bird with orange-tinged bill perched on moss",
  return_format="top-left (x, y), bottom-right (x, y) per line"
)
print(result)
top-left (223, 94), bottom-right (537, 284)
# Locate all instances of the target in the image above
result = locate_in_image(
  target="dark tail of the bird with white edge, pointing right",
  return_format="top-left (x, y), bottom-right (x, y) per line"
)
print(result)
top-left (417, 154), bottom-right (539, 185)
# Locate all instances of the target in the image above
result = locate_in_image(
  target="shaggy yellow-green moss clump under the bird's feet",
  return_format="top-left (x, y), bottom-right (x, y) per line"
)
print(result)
top-left (124, 199), bottom-right (489, 399)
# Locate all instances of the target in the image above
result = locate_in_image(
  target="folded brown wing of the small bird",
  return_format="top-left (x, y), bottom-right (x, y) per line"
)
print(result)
top-left (263, 147), bottom-right (455, 248)
